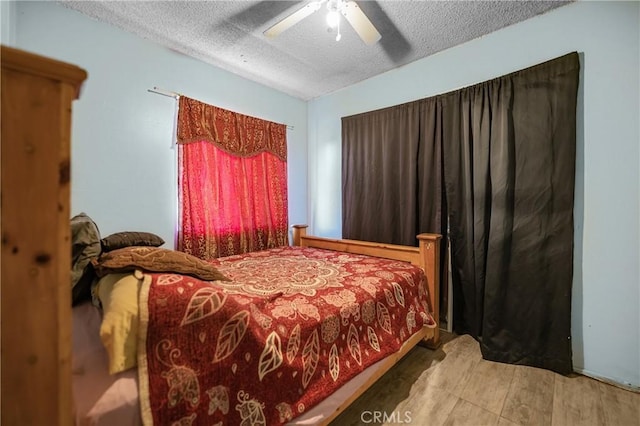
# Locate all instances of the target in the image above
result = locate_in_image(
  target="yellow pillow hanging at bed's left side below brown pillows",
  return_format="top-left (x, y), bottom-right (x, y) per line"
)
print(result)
top-left (95, 271), bottom-right (144, 374)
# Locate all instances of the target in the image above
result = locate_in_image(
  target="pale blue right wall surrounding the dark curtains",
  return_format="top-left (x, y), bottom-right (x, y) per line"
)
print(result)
top-left (309, 2), bottom-right (640, 387)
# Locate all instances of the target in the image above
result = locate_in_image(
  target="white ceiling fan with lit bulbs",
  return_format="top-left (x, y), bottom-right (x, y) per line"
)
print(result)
top-left (264, 0), bottom-right (382, 44)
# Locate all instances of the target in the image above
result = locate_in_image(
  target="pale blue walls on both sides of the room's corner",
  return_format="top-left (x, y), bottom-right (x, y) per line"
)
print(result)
top-left (7, 1), bottom-right (640, 387)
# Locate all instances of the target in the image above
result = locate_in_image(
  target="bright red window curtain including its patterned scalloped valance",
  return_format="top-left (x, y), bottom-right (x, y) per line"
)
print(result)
top-left (178, 97), bottom-right (288, 259)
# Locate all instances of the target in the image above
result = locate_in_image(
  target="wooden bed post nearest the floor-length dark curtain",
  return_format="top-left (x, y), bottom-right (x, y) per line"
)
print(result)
top-left (418, 234), bottom-right (442, 349)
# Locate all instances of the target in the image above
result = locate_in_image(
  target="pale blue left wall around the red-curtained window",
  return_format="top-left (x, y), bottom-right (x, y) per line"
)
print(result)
top-left (14, 2), bottom-right (307, 247)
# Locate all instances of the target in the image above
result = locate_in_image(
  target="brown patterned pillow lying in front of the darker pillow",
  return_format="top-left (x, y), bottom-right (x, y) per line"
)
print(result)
top-left (92, 246), bottom-right (230, 281)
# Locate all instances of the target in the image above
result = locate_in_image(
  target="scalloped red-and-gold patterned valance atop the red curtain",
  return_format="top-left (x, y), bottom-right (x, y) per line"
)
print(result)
top-left (178, 96), bottom-right (287, 161)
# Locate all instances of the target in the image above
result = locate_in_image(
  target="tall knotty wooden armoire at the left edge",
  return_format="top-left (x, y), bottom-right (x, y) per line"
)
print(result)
top-left (0, 46), bottom-right (87, 426)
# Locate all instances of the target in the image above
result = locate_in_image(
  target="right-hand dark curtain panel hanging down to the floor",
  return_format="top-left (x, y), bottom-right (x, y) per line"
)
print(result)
top-left (441, 53), bottom-right (579, 373)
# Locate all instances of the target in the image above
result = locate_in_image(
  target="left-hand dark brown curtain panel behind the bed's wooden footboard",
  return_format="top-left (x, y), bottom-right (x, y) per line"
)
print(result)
top-left (342, 99), bottom-right (448, 321)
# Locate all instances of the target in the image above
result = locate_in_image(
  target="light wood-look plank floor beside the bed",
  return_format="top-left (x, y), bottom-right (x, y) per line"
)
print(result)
top-left (331, 333), bottom-right (640, 426)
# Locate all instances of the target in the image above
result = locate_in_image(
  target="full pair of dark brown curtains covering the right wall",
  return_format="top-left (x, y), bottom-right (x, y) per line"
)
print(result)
top-left (342, 53), bottom-right (580, 373)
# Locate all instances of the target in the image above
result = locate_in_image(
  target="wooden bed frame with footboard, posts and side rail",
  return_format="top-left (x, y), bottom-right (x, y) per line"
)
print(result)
top-left (293, 225), bottom-right (441, 425)
